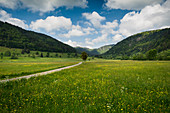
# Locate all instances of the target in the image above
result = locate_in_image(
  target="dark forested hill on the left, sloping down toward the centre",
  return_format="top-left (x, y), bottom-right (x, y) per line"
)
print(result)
top-left (0, 21), bottom-right (76, 53)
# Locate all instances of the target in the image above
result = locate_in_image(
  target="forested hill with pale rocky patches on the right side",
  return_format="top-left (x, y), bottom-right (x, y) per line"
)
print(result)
top-left (102, 28), bottom-right (170, 58)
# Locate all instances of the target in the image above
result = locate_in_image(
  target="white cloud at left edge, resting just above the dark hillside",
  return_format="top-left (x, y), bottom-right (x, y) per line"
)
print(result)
top-left (0, 10), bottom-right (28, 29)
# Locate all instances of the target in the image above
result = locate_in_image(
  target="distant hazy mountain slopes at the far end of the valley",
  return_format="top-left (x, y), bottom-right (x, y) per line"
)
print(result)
top-left (76, 44), bottom-right (114, 55)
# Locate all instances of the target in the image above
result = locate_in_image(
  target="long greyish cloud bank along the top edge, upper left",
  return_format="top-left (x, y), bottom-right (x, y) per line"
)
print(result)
top-left (0, 0), bottom-right (88, 13)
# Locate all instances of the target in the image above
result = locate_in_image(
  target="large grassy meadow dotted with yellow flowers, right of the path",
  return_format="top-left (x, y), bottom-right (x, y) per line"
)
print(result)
top-left (0, 61), bottom-right (170, 113)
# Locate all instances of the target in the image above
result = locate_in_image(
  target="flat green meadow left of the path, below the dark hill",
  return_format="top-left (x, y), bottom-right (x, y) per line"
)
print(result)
top-left (0, 57), bottom-right (80, 79)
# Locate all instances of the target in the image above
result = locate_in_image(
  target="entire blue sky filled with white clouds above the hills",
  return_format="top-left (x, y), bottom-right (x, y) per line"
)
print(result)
top-left (0, 0), bottom-right (170, 48)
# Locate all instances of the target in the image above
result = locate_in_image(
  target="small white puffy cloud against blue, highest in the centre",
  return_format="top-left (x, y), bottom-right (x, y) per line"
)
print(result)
top-left (82, 11), bottom-right (106, 28)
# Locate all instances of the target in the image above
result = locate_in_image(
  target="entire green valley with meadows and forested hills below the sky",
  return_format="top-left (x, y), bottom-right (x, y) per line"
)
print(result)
top-left (0, 15), bottom-right (170, 113)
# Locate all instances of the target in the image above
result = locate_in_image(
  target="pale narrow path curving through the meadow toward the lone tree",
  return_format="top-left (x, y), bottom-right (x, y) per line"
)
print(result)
top-left (0, 62), bottom-right (82, 82)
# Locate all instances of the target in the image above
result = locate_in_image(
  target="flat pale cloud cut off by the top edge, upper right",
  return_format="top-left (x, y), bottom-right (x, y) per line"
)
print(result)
top-left (105, 0), bottom-right (164, 10)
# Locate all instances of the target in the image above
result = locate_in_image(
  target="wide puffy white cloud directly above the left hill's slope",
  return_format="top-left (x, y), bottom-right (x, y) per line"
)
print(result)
top-left (30, 16), bottom-right (72, 32)
